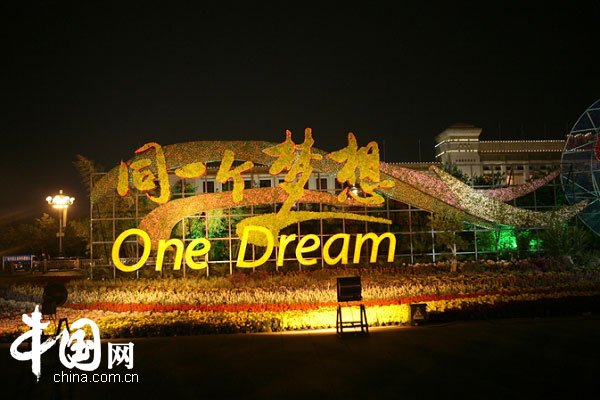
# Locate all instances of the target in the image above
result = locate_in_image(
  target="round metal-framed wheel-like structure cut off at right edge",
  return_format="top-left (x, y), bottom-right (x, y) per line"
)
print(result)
top-left (561, 100), bottom-right (600, 235)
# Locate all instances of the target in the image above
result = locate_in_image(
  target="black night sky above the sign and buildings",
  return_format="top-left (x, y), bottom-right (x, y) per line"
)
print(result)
top-left (0, 1), bottom-right (600, 219)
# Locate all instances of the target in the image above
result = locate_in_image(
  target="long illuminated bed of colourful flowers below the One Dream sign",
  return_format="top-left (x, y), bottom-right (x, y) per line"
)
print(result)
top-left (0, 262), bottom-right (600, 340)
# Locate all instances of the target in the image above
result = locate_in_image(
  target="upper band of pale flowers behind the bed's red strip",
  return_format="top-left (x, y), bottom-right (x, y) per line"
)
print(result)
top-left (2, 263), bottom-right (600, 307)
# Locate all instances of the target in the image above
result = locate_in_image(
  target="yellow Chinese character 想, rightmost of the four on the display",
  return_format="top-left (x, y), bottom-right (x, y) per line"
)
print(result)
top-left (327, 132), bottom-right (394, 204)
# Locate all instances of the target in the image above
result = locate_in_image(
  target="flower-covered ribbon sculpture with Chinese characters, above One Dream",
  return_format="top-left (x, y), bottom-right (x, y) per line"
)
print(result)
top-left (91, 129), bottom-right (586, 256)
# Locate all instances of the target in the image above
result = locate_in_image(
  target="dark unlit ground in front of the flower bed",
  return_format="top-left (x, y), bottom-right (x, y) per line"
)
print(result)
top-left (0, 316), bottom-right (600, 400)
